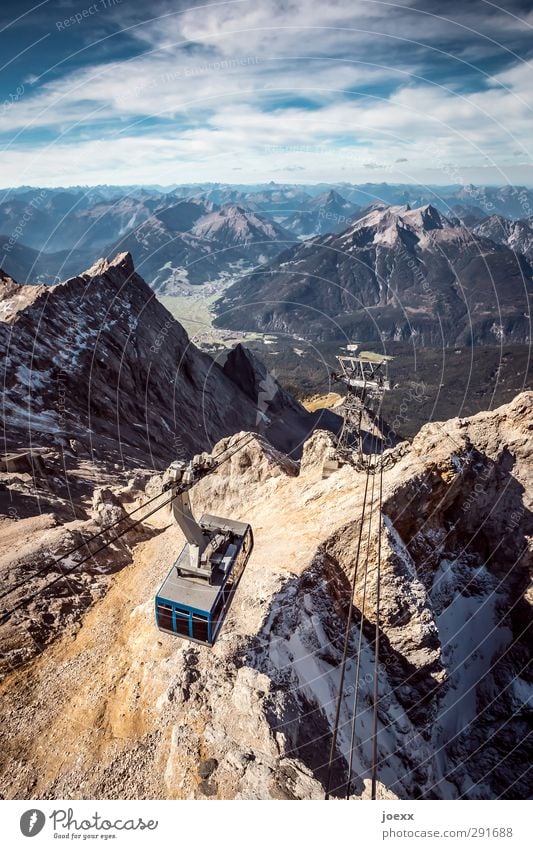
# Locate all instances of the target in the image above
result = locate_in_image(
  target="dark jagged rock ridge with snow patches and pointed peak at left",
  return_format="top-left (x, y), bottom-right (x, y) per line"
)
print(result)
top-left (0, 254), bottom-right (326, 468)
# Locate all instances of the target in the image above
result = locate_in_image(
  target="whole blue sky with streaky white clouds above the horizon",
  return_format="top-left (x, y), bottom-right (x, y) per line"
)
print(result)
top-left (0, 0), bottom-right (533, 187)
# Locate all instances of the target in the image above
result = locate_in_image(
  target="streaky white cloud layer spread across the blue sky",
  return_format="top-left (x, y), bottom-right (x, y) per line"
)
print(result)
top-left (0, 0), bottom-right (533, 185)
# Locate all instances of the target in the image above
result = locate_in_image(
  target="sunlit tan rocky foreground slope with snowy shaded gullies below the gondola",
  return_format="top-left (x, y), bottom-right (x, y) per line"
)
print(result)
top-left (0, 393), bottom-right (533, 799)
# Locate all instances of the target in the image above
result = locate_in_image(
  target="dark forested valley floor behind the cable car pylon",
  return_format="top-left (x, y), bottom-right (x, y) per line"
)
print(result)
top-left (237, 336), bottom-right (533, 439)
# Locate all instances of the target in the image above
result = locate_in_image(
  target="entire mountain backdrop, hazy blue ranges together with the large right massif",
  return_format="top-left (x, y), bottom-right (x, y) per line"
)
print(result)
top-left (0, 184), bottom-right (533, 345)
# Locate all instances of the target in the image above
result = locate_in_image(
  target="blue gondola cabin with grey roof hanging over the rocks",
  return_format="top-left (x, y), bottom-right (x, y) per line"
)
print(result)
top-left (155, 514), bottom-right (253, 646)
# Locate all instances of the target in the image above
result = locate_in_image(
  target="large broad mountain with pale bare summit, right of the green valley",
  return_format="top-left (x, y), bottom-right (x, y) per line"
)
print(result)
top-left (216, 205), bottom-right (533, 347)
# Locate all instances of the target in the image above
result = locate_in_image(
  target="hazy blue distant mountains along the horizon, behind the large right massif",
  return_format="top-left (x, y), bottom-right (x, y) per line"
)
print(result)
top-left (0, 183), bottom-right (533, 294)
